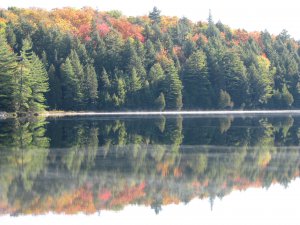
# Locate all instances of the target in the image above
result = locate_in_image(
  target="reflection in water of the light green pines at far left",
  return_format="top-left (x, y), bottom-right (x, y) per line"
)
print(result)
top-left (0, 119), bottom-right (49, 214)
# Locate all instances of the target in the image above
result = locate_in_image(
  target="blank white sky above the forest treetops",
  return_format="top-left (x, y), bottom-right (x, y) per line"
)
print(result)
top-left (0, 0), bottom-right (300, 40)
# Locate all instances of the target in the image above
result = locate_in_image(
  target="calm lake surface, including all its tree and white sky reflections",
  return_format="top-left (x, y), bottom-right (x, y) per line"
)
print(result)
top-left (0, 115), bottom-right (300, 225)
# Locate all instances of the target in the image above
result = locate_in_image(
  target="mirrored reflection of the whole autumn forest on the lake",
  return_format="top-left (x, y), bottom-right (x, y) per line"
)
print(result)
top-left (0, 116), bottom-right (300, 215)
